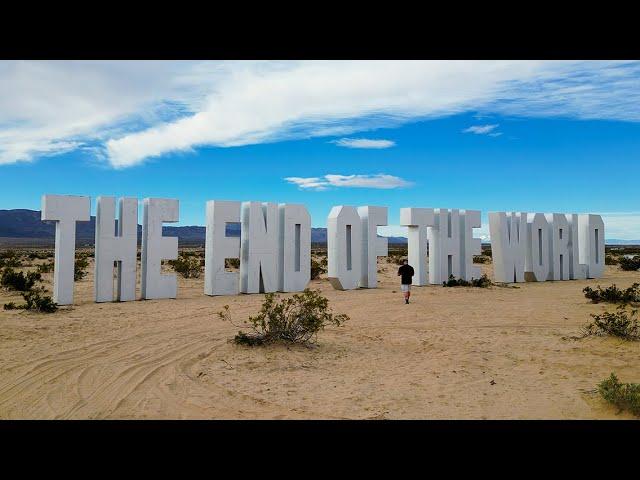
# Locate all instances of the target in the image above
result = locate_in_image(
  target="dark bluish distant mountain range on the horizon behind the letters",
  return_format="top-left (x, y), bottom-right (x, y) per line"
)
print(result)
top-left (0, 209), bottom-right (407, 245)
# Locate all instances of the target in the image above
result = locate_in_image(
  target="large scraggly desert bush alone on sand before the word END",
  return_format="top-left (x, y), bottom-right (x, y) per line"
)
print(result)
top-left (218, 288), bottom-right (349, 346)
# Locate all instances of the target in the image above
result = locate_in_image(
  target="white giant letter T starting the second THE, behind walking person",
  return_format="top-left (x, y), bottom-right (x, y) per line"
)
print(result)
top-left (400, 208), bottom-right (435, 285)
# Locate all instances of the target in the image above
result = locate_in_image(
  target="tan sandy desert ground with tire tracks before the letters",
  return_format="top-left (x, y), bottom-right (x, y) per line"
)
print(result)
top-left (0, 261), bottom-right (640, 419)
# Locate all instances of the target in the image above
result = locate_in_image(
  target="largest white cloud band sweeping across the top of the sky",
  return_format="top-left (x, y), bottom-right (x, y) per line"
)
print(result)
top-left (0, 61), bottom-right (640, 168)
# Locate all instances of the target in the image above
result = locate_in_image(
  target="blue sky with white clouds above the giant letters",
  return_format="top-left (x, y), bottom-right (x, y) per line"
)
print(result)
top-left (0, 62), bottom-right (640, 239)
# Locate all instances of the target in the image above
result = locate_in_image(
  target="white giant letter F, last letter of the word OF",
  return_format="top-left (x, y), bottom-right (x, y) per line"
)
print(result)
top-left (358, 206), bottom-right (389, 288)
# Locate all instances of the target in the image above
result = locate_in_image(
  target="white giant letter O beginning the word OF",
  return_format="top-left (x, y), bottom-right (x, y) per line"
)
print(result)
top-left (327, 206), bottom-right (362, 290)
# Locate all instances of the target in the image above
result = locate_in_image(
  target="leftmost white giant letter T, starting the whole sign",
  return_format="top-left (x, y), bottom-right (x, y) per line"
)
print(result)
top-left (41, 195), bottom-right (91, 305)
